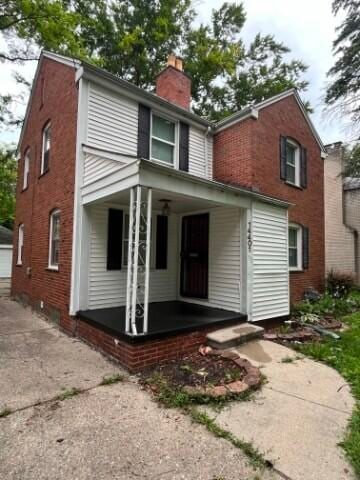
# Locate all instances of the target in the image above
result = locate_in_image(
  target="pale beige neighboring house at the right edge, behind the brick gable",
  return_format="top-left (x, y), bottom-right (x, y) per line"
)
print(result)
top-left (324, 142), bottom-right (360, 282)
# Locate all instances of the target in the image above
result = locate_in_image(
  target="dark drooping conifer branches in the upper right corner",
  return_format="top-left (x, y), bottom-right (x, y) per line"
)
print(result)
top-left (325, 0), bottom-right (360, 128)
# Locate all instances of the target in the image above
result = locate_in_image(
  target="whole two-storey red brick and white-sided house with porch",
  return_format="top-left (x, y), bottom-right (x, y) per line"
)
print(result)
top-left (12, 52), bottom-right (325, 370)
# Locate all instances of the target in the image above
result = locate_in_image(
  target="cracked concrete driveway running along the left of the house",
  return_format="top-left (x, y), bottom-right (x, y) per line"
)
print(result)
top-left (0, 299), bottom-right (283, 480)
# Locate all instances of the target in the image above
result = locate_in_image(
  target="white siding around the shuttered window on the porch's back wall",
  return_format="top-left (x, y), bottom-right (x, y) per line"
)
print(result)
top-left (89, 205), bottom-right (178, 309)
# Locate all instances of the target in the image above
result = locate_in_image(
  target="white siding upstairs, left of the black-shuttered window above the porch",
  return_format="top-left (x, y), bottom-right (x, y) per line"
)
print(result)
top-left (86, 84), bottom-right (138, 155)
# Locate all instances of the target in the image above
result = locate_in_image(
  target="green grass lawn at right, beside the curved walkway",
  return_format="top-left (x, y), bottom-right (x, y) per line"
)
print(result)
top-left (296, 308), bottom-right (360, 478)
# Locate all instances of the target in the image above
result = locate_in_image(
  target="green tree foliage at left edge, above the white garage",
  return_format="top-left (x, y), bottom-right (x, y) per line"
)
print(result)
top-left (0, 147), bottom-right (17, 228)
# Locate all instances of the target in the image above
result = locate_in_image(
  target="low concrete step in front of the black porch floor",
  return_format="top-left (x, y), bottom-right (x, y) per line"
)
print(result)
top-left (206, 323), bottom-right (264, 350)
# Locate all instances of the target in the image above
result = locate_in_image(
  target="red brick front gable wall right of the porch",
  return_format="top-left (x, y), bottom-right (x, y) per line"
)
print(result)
top-left (214, 96), bottom-right (325, 302)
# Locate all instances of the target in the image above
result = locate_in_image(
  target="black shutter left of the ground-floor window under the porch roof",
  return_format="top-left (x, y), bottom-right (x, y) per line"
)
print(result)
top-left (107, 208), bottom-right (123, 270)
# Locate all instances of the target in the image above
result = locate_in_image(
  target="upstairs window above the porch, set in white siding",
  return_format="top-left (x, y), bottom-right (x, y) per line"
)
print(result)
top-left (150, 115), bottom-right (176, 165)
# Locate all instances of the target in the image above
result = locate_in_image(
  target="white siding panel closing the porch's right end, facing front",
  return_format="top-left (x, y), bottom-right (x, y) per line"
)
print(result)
top-left (251, 203), bottom-right (289, 321)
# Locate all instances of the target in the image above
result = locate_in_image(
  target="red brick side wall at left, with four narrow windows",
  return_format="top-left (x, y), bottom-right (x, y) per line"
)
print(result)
top-left (12, 58), bottom-right (78, 328)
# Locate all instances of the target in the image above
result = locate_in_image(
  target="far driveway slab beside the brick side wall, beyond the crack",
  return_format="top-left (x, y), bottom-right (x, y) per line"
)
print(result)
top-left (0, 299), bottom-right (121, 410)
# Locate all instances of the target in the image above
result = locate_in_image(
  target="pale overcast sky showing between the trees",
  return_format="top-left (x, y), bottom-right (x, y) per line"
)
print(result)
top-left (0, 0), bottom-right (351, 143)
